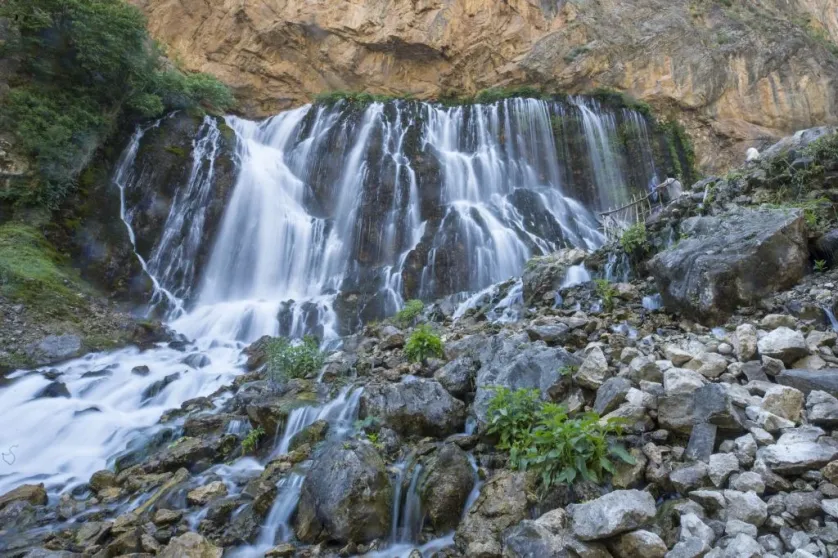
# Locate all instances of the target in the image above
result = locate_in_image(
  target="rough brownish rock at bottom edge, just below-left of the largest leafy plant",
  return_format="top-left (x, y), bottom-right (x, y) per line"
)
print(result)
top-left (454, 471), bottom-right (533, 558)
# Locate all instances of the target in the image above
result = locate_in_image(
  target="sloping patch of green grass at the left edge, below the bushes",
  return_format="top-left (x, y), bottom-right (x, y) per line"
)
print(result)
top-left (0, 223), bottom-right (86, 317)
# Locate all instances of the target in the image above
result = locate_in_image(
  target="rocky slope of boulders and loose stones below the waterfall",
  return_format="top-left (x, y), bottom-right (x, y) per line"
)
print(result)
top-left (0, 129), bottom-right (838, 558)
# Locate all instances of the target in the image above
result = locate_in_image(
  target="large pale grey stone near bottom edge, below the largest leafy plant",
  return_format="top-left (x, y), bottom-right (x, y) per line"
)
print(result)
top-left (568, 490), bottom-right (655, 541)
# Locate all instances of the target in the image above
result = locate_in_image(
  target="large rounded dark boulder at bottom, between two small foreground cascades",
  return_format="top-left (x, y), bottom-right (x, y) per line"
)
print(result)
top-left (296, 441), bottom-right (392, 543)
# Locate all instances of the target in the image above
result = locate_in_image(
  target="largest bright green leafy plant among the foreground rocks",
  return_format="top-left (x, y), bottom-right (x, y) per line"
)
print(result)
top-left (488, 388), bottom-right (634, 490)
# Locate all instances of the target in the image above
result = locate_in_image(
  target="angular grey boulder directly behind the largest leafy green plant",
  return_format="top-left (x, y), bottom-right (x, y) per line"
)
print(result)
top-left (474, 332), bottom-right (581, 422)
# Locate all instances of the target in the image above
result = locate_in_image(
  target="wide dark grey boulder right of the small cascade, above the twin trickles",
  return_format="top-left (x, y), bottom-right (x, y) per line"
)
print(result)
top-left (359, 377), bottom-right (466, 437)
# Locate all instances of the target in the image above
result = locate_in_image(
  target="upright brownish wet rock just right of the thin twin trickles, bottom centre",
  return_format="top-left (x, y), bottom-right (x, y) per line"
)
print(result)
top-left (419, 443), bottom-right (474, 533)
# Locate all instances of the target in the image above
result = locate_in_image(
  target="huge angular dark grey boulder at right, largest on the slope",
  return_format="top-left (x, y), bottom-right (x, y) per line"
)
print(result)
top-left (649, 209), bottom-right (809, 323)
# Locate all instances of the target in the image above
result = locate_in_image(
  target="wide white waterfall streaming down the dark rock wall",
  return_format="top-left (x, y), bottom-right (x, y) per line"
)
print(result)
top-left (123, 98), bottom-right (661, 341)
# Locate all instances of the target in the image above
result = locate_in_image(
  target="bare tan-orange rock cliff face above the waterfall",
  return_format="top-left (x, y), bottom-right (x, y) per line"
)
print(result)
top-left (133, 0), bottom-right (838, 170)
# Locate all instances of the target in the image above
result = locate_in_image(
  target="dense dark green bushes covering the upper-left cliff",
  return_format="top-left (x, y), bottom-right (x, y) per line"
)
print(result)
top-left (0, 0), bottom-right (233, 208)
